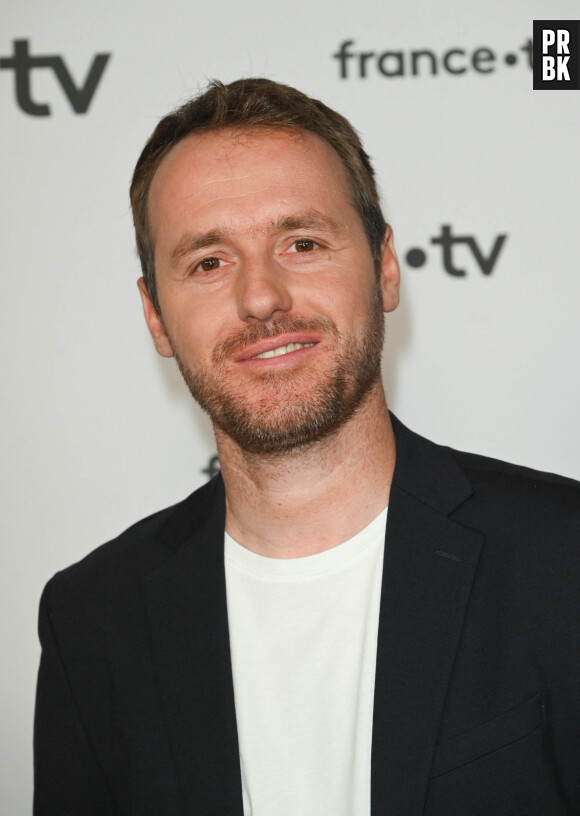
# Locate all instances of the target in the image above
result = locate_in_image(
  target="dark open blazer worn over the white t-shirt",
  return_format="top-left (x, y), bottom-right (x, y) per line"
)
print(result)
top-left (34, 419), bottom-right (580, 816)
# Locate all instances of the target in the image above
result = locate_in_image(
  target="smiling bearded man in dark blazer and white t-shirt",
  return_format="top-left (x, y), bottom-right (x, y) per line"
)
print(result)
top-left (35, 79), bottom-right (580, 816)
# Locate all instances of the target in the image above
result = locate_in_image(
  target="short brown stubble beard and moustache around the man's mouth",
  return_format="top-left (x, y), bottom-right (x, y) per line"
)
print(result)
top-left (174, 287), bottom-right (384, 455)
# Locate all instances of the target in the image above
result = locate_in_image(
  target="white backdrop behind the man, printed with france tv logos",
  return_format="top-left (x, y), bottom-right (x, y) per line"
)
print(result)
top-left (0, 0), bottom-right (580, 816)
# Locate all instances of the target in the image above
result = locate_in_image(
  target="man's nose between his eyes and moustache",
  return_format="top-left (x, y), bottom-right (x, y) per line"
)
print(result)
top-left (237, 256), bottom-right (292, 321)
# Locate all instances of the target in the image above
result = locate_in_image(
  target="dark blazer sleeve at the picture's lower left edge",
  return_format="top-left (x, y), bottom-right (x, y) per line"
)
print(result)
top-left (33, 587), bottom-right (117, 816)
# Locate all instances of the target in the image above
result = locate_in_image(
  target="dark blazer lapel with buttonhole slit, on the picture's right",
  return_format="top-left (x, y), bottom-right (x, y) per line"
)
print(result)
top-left (371, 417), bottom-right (483, 816)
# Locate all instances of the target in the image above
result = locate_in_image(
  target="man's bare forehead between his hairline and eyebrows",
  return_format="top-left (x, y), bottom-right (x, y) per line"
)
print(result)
top-left (148, 128), bottom-right (357, 240)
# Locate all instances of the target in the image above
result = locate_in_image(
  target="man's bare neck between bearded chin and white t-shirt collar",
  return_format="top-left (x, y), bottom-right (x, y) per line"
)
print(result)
top-left (215, 382), bottom-right (395, 558)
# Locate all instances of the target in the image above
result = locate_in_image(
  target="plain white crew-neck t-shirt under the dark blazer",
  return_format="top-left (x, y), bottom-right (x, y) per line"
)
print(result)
top-left (225, 509), bottom-right (387, 816)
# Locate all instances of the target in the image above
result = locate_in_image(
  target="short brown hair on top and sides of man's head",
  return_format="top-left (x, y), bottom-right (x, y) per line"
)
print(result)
top-left (131, 77), bottom-right (387, 312)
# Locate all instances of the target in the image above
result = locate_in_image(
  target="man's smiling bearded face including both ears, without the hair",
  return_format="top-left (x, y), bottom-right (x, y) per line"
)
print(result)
top-left (140, 129), bottom-right (398, 453)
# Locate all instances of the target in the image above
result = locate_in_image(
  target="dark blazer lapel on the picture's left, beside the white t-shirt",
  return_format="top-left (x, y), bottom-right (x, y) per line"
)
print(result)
top-left (144, 476), bottom-right (243, 816)
